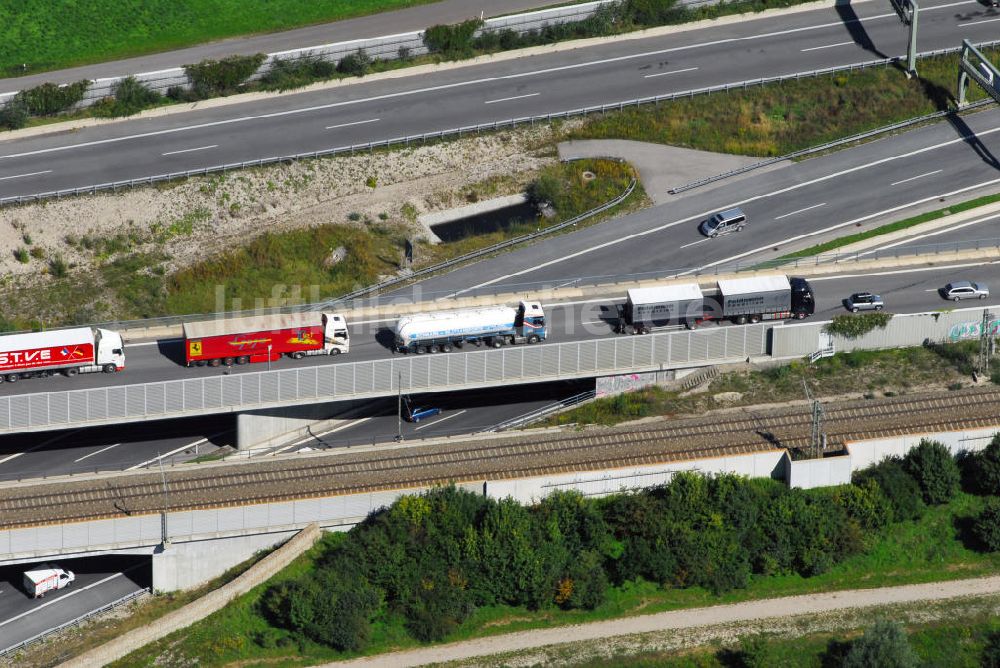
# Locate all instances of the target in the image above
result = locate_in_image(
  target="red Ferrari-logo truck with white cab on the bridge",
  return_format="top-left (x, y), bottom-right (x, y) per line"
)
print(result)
top-left (184, 312), bottom-right (351, 366)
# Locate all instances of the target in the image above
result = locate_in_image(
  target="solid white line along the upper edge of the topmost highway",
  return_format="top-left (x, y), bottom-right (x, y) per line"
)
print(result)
top-left (0, 0), bottom-right (978, 160)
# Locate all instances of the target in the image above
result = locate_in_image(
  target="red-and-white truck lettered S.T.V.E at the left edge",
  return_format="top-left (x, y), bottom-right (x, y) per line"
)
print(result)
top-left (0, 327), bottom-right (125, 383)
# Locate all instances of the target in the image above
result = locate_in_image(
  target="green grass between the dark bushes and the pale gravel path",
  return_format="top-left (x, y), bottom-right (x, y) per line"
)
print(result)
top-left (107, 494), bottom-right (1000, 666)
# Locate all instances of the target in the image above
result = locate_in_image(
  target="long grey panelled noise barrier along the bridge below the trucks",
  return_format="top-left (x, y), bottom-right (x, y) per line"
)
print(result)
top-left (0, 324), bottom-right (772, 433)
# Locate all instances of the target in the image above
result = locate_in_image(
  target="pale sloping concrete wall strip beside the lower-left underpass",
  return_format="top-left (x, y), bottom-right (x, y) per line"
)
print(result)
top-left (61, 524), bottom-right (320, 668)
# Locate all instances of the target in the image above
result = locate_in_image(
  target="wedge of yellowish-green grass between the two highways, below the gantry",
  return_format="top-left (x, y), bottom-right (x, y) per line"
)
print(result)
top-left (567, 49), bottom-right (1000, 157)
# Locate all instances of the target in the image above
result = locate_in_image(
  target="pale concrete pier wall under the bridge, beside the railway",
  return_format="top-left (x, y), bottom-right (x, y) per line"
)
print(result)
top-left (236, 401), bottom-right (371, 450)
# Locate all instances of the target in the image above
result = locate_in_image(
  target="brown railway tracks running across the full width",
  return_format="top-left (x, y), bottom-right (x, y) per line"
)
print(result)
top-left (0, 389), bottom-right (1000, 528)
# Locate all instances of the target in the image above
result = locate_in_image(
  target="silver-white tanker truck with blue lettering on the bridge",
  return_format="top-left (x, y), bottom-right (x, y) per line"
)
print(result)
top-left (393, 302), bottom-right (546, 355)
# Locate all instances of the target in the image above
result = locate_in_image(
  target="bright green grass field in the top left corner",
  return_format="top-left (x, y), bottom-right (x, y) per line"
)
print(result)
top-left (0, 0), bottom-right (432, 76)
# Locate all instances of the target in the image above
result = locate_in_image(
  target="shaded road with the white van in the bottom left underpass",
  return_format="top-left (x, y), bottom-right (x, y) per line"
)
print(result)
top-left (0, 556), bottom-right (152, 650)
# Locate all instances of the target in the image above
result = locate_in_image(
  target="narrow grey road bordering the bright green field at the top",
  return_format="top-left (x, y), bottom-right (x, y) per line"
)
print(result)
top-left (0, 0), bottom-right (553, 93)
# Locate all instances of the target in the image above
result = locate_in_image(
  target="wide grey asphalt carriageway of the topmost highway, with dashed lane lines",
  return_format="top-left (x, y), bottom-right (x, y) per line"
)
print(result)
top-left (0, 0), bottom-right (1000, 197)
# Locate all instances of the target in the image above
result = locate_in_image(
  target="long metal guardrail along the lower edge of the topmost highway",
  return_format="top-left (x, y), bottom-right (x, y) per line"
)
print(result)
top-left (0, 40), bottom-right (1000, 206)
